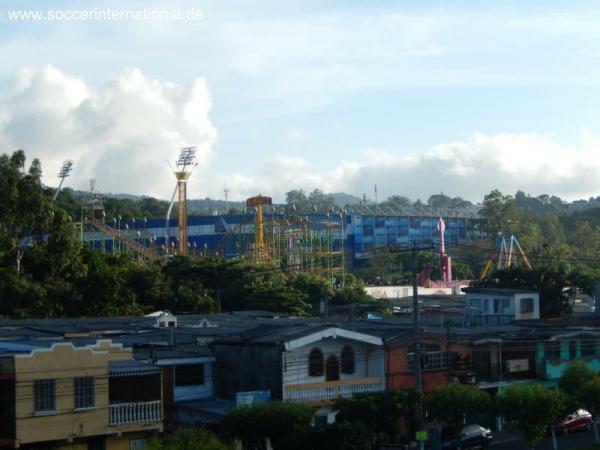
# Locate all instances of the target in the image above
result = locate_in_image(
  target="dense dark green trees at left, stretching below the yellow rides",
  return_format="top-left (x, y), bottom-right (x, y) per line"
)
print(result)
top-left (0, 151), bottom-right (374, 317)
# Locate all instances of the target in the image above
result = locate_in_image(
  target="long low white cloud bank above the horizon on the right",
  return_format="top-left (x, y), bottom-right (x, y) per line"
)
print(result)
top-left (218, 132), bottom-right (600, 202)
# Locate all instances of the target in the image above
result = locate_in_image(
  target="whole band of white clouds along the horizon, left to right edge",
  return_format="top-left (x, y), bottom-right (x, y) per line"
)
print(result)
top-left (0, 67), bottom-right (600, 206)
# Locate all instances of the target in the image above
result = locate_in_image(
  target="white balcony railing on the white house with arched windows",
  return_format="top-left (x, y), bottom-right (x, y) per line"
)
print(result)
top-left (283, 377), bottom-right (385, 403)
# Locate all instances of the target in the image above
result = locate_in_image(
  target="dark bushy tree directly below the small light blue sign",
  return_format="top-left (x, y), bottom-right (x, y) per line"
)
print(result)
top-left (225, 402), bottom-right (313, 450)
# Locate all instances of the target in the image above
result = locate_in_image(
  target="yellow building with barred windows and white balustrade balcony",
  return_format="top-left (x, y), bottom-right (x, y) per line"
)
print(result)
top-left (0, 340), bottom-right (163, 450)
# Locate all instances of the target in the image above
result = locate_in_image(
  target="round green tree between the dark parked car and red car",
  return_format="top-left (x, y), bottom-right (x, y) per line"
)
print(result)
top-left (498, 384), bottom-right (566, 448)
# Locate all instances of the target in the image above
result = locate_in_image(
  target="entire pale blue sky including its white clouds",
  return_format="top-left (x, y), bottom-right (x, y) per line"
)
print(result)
top-left (0, 0), bottom-right (600, 202)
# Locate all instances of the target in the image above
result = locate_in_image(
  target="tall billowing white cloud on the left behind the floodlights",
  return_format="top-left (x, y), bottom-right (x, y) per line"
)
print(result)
top-left (0, 66), bottom-right (217, 197)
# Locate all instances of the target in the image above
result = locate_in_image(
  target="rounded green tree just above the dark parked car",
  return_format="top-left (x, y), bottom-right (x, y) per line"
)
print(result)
top-left (425, 383), bottom-right (491, 424)
